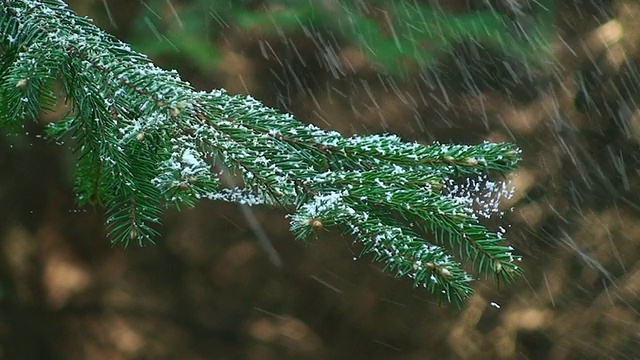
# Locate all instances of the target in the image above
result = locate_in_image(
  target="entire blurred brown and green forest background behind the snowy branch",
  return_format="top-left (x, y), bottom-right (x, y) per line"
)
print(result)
top-left (0, 0), bottom-right (640, 360)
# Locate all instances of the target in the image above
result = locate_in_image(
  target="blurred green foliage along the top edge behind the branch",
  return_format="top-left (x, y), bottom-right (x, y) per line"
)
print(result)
top-left (131, 0), bottom-right (556, 78)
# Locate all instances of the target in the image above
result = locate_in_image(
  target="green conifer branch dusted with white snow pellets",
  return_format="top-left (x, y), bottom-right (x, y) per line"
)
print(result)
top-left (0, 0), bottom-right (521, 303)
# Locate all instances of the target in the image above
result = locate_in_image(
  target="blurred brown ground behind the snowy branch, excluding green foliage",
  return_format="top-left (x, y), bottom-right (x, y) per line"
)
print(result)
top-left (0, 0), bottom-right (640, 360)
